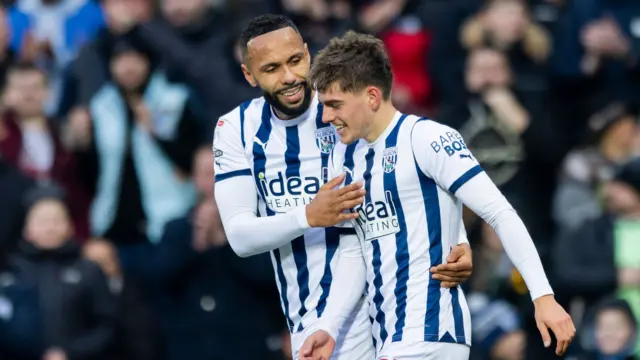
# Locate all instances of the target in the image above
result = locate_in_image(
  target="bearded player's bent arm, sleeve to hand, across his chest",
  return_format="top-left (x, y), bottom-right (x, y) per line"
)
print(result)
top-left (213, 113), bottom-right (362, 257)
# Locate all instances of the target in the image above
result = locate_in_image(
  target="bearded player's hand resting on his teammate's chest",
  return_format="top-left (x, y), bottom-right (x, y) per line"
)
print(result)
top-left (306, 174), bottom-right (365, 227)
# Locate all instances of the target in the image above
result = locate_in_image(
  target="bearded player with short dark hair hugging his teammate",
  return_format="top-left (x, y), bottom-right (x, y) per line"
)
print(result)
top-left (213, 15), bottom-right (471, 360)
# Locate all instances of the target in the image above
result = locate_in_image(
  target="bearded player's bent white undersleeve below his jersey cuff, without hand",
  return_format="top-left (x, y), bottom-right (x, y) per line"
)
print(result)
top-left (216, 177), bottom-right (309, 257)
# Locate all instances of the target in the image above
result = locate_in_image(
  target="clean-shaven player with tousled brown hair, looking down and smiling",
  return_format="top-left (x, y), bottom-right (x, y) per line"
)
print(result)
top-left (301, 32), bottom-right (575, 360)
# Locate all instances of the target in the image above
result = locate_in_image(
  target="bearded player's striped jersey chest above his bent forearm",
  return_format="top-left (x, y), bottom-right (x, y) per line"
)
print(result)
top-left (245, 100), bottom-right (336, 216)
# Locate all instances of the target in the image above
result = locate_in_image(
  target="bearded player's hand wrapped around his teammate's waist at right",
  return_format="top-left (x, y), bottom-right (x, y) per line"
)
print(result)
top-left (431, 244), bottom-right (473, 288)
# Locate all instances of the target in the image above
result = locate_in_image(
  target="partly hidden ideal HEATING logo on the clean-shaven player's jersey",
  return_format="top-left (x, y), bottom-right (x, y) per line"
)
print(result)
top-left (355, 191), bottom-right (400, 241)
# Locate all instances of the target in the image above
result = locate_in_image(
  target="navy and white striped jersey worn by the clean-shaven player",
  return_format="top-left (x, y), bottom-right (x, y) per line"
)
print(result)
top-left (330, 113), bottom-right (482, 351)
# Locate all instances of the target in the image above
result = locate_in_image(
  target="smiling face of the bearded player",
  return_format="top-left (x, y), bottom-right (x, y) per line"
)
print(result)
top-left (242, 27), bottom-right (311, 118)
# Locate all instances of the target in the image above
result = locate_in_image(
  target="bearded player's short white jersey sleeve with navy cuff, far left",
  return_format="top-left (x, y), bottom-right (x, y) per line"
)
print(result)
top-left (213, 109), bottom-right (251, 182)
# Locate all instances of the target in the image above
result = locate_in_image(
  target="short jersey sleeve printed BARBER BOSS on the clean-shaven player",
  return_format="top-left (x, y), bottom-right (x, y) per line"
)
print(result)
top-left (411, 120), bottom-right (483, 194)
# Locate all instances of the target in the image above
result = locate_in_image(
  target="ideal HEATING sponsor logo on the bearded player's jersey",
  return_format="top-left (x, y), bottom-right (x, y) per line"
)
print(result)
top-left (258, 171), bottom-right (328, 213)
